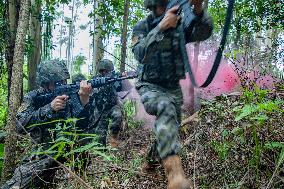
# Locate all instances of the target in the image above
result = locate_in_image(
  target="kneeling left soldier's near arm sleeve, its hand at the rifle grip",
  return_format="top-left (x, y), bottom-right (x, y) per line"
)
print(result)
top-left (16, 91), bottom-right (55, 133)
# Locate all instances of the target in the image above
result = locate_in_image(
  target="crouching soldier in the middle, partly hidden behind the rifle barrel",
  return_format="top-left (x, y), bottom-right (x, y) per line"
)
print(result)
top-left (91, 59), bottom-right (123, 147)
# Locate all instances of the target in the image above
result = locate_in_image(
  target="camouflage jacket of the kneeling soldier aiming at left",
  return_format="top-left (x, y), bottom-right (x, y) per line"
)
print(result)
top-left (16, 88), bottom-right (92, 144)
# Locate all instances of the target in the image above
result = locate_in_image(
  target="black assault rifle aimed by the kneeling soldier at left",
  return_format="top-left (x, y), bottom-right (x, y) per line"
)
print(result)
top-left (35, 75), bottom-right (137, 106)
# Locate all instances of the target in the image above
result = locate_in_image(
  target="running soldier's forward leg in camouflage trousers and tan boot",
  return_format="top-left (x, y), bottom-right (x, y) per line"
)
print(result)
top-left (139, 87), bottom-right (191, 189)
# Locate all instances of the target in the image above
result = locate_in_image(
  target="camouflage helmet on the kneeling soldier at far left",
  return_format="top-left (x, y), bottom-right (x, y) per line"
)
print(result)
top-left (36, 59), bottom-right (70, 86)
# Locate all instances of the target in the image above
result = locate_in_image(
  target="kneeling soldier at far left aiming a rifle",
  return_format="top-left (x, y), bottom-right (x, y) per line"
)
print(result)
top-left (2, 59), bottom-right (92, 189)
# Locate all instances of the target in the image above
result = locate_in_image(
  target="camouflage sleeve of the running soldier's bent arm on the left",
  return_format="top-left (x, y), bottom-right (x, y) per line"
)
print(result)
top-left (132, 20), bottom-right (162, 63)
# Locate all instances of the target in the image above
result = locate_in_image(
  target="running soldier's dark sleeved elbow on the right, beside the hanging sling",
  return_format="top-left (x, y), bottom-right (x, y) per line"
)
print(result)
top-left (186, 11), bottom-right (213, 42)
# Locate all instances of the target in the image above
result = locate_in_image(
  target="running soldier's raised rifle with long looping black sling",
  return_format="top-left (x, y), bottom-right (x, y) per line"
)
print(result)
top-left (151, 0), bottom-right (235, 87)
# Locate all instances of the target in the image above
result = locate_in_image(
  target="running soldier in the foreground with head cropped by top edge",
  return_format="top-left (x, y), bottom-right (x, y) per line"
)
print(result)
top-left (132, 0), bottom-right (213, 189)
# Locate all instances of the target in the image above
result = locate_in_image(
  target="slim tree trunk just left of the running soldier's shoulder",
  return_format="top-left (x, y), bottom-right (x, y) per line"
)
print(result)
top-left (120, 0), bottom-right (130, 73)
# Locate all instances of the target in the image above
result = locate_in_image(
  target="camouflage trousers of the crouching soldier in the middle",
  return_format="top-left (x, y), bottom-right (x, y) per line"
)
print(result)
top-left (94, 104), bottom-right (123, 145)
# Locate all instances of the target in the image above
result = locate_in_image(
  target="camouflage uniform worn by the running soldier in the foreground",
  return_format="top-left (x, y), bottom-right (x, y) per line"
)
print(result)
top-left (132, 3), bottom-right (213, 159)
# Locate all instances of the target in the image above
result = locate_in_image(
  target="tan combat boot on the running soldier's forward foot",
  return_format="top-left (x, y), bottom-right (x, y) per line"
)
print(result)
top-left (163, 155), bottom-right (193, 189)
